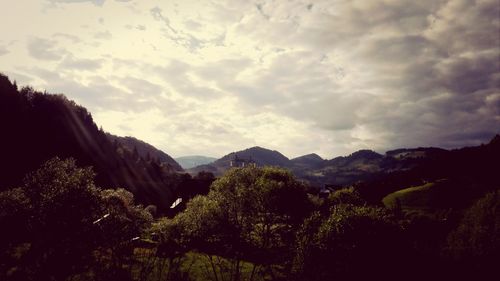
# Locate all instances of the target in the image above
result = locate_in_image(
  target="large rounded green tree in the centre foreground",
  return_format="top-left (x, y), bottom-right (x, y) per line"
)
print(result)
top-left (160, 167), bottom-right (310, 280)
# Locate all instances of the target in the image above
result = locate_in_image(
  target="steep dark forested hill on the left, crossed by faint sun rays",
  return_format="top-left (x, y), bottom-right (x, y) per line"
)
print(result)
top-left (0, 74), bottom-right (179, 208)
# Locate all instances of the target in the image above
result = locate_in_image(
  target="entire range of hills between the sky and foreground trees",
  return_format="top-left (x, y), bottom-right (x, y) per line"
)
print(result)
top-left (0, 74), bottom-right (500, 209)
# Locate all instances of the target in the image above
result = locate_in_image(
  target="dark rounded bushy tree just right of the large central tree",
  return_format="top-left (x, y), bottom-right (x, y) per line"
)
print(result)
top-left (293, 204), bottom-right (405, 280)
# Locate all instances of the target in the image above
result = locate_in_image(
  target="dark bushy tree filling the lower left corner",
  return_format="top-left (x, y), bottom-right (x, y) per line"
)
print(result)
top-left (0, 158), bottom-right (151, 280)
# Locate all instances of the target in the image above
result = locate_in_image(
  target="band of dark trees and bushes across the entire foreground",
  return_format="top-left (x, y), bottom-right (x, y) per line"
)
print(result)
top-left (0, 158), bottom-right (500, 280)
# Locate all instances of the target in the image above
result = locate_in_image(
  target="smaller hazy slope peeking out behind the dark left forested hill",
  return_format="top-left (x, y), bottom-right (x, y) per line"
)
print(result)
top-left (106, 133), bottom-right (183, 172)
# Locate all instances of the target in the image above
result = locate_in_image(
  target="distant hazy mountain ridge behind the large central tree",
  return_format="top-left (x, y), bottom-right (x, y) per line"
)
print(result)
top-left (187, 146), bottom-right (462, 187)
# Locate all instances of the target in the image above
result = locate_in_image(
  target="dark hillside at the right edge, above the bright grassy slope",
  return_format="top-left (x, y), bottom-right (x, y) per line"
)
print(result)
top-left (357, 135), bottom-right (500, 203)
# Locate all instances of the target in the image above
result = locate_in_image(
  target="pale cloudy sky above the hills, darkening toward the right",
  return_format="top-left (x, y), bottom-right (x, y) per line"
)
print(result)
top-left (0, 0), bottom-right (500, 159)
